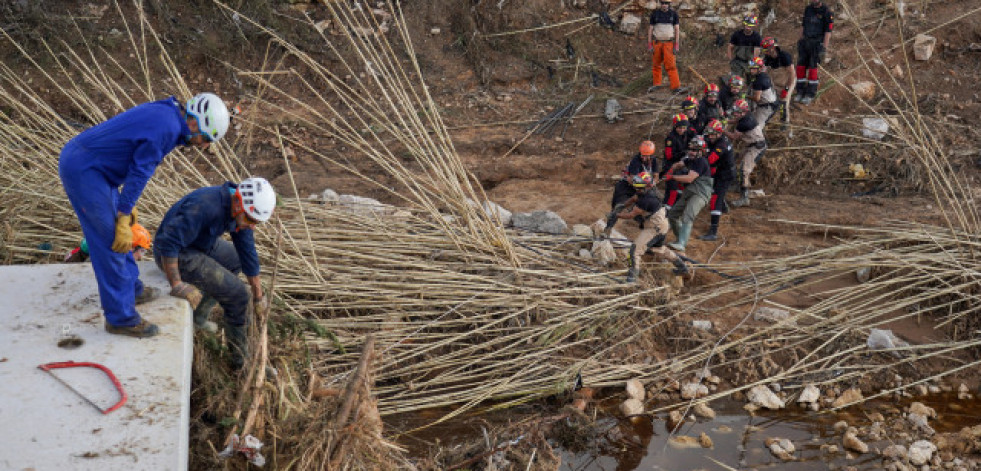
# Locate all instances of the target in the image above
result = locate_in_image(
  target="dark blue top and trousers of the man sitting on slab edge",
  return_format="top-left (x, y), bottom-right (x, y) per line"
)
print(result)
top-left (153, 182), bottom-right (259, 326)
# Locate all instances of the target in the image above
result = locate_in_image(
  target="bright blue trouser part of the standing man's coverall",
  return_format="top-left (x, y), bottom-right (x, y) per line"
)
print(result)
top-left (58, 148), bottom-right (143, 327)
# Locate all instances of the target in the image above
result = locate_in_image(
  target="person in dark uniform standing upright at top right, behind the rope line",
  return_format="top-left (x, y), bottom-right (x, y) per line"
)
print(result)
top-left (794, 0), bottom-right (834, 105)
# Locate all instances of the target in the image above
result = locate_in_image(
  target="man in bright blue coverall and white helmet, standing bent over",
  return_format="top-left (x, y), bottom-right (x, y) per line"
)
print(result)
top-left (58, 93), bottom-right (231, 338)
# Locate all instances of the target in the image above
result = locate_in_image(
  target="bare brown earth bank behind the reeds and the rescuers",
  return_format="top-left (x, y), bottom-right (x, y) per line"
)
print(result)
top-left (0, 0), bottom-right (981, 470)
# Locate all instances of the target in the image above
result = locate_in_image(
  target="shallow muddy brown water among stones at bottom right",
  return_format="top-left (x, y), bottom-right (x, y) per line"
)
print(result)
top-left (559, 395), bottom-right (981, 471)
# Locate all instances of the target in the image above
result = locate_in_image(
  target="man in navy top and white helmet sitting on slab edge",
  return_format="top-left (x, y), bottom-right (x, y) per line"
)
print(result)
top-left (154, 177), bottom-right (276, 369)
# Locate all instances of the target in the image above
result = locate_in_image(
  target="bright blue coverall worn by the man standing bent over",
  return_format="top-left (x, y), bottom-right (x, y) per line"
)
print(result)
top-left (58, 97), bottom-right (191, 327)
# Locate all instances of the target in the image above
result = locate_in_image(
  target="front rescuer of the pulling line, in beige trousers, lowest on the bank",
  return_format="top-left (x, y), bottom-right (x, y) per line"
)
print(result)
top-left (605, 172), bottom-right (688, 283)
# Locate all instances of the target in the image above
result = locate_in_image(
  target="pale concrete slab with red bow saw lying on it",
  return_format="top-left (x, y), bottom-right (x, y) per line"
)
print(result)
top-left (0, 262), bottom-right (193, 471)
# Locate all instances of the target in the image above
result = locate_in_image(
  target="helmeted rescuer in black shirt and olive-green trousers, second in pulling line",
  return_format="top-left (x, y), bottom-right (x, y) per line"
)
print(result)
top-left (664, 136), bottom-right (712, 252)
